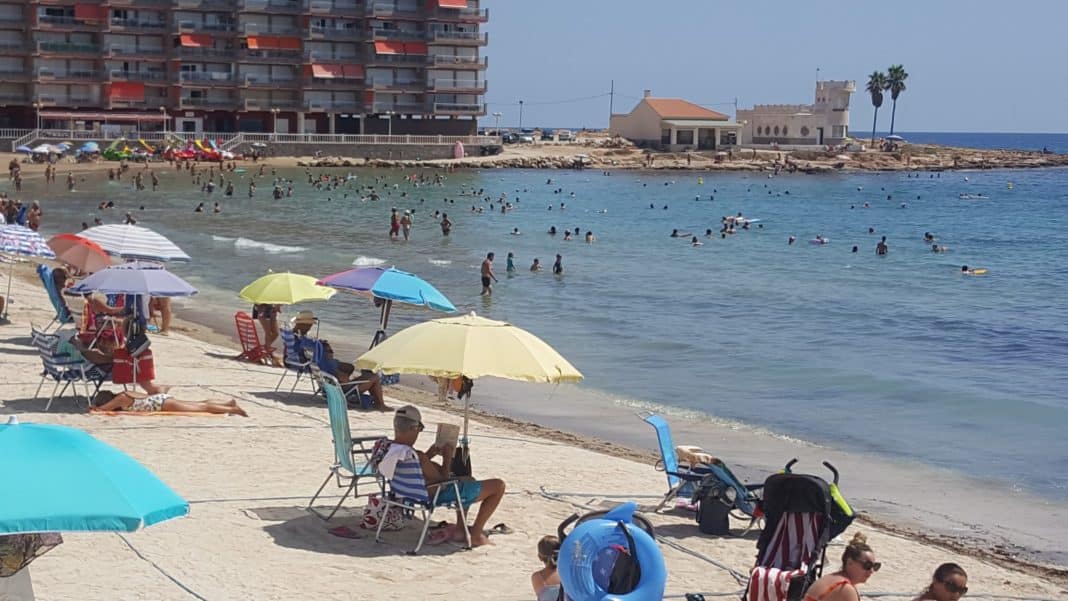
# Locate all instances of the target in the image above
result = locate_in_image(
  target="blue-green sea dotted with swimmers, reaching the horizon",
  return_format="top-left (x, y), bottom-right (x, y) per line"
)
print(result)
top-left (23, 160), bottom-right (1068, 502)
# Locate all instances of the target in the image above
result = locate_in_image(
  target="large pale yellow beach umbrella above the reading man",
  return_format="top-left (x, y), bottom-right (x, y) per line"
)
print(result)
top-left (356, 313), bottom-right (582, 456)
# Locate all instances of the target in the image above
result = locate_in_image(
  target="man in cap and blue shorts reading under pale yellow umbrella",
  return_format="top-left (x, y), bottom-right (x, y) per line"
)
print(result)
top-left (378, 405), bottom-right (504, 547)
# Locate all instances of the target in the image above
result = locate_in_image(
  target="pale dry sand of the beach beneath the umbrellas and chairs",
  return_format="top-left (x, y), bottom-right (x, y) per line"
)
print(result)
top-left (0, 267), bottom-right (1068, 600)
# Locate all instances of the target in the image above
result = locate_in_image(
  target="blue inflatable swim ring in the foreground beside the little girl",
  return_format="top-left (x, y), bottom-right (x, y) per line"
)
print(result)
top-left (556, 502), bottom-right (668, 601)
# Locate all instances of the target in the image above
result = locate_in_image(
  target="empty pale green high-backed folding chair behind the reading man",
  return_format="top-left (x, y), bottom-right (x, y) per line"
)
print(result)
top-left (308, 373), bottom-right (386, 521)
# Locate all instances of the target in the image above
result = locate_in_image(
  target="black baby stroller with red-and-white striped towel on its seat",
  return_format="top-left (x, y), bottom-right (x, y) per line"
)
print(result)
top-left (742, 459), bottom-right (854, 601)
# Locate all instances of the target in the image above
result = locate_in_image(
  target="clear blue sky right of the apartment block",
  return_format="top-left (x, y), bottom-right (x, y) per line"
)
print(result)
top-left (482, 0), bottom-right (1068, 133)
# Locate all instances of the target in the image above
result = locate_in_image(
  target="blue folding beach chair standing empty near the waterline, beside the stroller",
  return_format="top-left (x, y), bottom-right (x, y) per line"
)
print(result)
top-left (638, 411), bottom-right (764, 531)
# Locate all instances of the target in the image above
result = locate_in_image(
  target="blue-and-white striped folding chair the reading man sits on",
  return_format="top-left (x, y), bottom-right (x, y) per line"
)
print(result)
top-left (375, 452), bottom-right (471, 555)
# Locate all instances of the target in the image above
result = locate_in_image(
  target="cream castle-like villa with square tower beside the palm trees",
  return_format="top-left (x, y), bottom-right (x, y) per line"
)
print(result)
top-left (735, 81), bottom-right (857, 146)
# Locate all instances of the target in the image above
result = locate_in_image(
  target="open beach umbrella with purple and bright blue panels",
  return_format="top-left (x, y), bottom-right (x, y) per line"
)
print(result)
top-left (317, 267), bottom-right (456, 348)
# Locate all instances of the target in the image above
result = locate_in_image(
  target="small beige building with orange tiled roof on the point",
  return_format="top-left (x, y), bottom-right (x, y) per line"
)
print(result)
top-left (609, 90), bottom-right (741, 152)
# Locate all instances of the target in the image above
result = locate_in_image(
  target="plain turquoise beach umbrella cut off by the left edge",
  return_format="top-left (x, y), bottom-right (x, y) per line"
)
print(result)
top-left (0, 418), bottom-right (189, 535)
